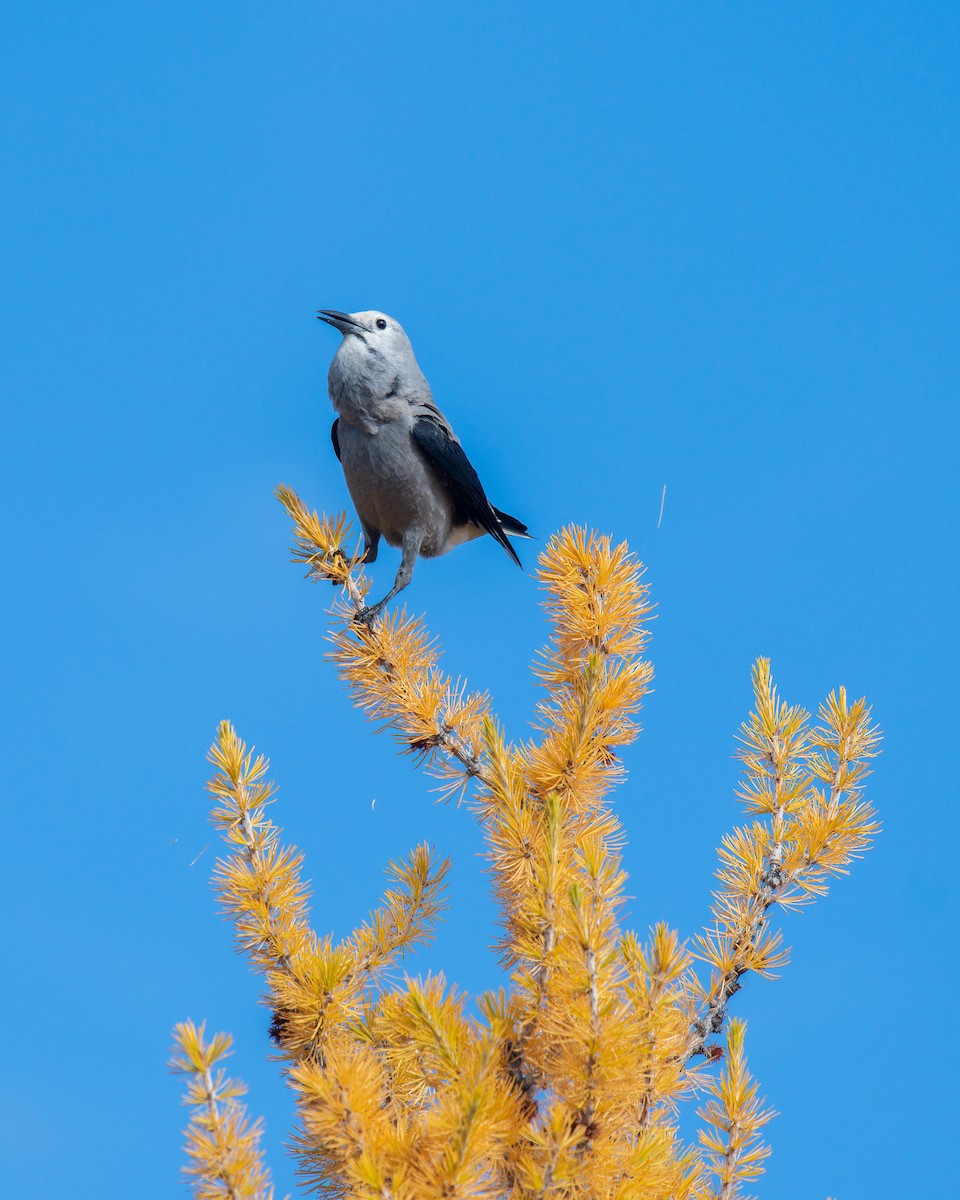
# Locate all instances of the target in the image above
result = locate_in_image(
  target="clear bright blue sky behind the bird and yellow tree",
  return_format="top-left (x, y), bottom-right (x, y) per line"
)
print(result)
top-left (0, 0), bottom-right (960, 1200)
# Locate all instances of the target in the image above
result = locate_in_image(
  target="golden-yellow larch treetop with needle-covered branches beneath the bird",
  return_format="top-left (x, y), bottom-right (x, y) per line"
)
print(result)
top-left (170, 488), bottom-right (878, 1200)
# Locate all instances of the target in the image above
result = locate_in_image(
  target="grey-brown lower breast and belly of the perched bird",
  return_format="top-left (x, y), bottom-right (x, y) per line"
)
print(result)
top-left (338, 413), bottom-right (454, 558)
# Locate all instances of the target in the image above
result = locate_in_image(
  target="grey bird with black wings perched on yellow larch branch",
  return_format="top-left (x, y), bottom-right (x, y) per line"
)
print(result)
top-left (317, 308), bottom-right (530, 623)
